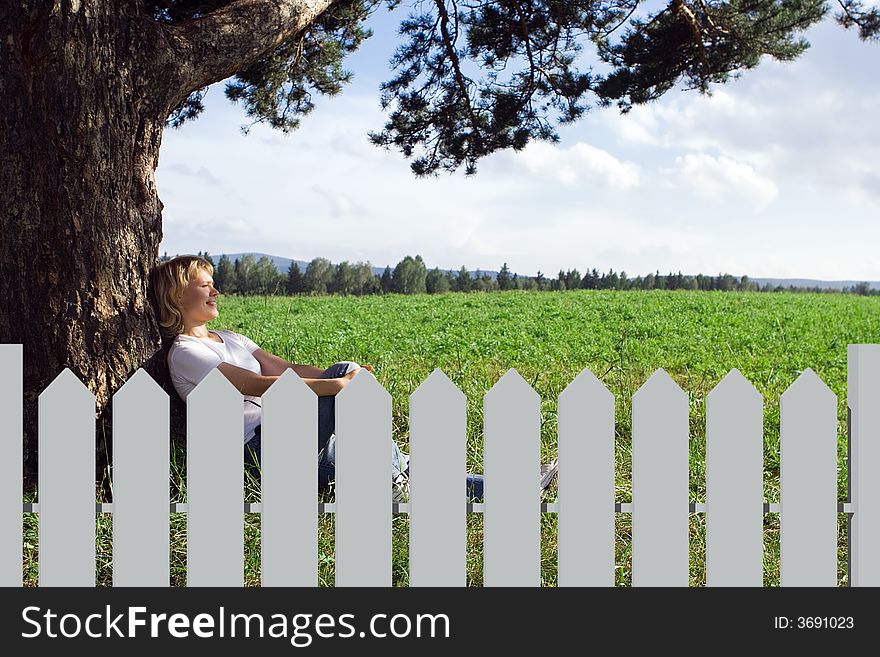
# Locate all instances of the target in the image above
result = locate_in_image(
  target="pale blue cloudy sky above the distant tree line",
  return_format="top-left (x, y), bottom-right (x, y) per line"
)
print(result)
top-left (156, 5), bottom-right (880, 281)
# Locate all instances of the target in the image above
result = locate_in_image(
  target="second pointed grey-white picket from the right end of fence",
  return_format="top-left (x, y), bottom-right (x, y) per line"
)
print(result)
top-left (706, 369), bottom-right (764, 586)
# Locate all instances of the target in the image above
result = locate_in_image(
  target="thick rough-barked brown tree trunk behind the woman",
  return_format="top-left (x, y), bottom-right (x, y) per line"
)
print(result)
top-left (0, 0), bottom-right (180, 482)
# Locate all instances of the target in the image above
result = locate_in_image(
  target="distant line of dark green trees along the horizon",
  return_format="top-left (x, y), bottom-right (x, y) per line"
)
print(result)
top-left (160, 251), bottom-right (880, 296)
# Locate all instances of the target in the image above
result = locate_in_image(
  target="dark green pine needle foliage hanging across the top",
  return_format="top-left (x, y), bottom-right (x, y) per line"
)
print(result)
top-left (150, 0), bottom-right (880, 175)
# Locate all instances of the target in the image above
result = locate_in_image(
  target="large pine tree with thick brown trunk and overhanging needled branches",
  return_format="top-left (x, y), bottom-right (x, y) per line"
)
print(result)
top-left (0, 0), bottom-right (880, 472)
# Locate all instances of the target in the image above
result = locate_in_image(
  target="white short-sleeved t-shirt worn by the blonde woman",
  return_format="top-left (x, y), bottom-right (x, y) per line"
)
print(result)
top-left (168, 331), bottom-right (262, 442)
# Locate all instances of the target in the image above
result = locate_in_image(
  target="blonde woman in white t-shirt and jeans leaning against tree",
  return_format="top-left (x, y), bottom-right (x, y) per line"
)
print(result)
top-left (155, 256), bottom-right (483, 501)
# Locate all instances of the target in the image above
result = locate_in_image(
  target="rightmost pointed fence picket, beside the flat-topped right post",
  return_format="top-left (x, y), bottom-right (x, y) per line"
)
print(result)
top-left (779, 369), bottom-right (837, 586)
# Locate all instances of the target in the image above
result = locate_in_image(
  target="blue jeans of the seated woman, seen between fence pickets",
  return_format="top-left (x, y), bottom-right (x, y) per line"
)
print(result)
top-left (244, 361), bottom-right (483, 502)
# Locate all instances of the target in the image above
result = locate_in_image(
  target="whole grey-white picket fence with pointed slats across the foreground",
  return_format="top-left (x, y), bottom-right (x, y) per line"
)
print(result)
top-left (0, 345), bottom-right (880, 586)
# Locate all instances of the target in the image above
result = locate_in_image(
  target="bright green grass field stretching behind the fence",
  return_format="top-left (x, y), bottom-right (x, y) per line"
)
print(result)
top-left (25, 291), bottom-right (880, 586)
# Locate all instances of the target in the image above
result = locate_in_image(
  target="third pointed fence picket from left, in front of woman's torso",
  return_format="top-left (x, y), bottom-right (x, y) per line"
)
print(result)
top-left (186, 369), bottom-right (244, 586)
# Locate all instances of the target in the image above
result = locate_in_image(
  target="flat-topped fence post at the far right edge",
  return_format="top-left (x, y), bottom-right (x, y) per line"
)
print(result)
top-left (847, 344), bottom-right (880, 586)
